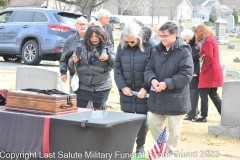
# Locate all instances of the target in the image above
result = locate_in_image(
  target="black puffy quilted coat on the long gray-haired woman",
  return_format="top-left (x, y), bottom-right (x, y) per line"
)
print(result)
top-left (114, 41), bottom-right (154, 114)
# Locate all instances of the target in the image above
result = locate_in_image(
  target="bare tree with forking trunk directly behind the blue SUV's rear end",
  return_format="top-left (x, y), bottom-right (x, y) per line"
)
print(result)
top-left (57, 0), bottom-right (108, 20)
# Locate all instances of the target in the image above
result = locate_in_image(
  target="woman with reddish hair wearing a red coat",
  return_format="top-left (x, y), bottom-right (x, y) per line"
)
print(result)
top-left (194, 24), bottom-right (223, 122)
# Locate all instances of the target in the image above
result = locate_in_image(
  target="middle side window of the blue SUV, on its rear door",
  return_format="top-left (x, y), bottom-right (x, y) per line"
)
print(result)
top-left (12, 11), bottom-right (33, 22)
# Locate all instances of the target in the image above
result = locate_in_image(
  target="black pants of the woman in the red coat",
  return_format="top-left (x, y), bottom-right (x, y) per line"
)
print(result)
top-left (199, 88), bottom-right (222, 117)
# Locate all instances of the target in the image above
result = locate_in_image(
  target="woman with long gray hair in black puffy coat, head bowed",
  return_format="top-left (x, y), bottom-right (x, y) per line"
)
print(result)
top-left (114, 22), bottom-right (154, 155)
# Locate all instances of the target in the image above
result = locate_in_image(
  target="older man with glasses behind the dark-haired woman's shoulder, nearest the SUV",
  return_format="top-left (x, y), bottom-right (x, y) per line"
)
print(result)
top-left (59, 17), bottom-right (88, 93)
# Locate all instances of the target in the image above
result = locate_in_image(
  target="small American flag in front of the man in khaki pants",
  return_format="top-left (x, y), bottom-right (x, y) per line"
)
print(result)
top-left (149, 127), bottom-right (167, 160)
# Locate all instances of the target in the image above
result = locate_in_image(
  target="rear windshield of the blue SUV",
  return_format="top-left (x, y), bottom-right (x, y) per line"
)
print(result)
top-left (55, 12), bottom-right (85, 26)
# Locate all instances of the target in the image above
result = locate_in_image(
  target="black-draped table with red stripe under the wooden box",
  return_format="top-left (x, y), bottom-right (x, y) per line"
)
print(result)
top-left (0, 106), bottom-right (146, 160)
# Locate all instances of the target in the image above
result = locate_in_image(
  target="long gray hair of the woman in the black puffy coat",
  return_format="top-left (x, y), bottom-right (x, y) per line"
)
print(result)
top-left (121, 22), bottom-right (144, 52)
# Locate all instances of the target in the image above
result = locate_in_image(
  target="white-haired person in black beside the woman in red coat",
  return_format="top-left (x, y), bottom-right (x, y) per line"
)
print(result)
top-left (181, 29), bottom-right (200, 121)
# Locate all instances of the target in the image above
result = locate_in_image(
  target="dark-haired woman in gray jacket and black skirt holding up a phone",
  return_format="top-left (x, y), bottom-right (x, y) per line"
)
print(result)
top-left (68, 26), bottom-right (115, 109)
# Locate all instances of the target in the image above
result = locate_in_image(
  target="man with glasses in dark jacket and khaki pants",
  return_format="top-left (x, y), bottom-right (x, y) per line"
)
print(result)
top-left (144, 22), bottom-right (193, 156)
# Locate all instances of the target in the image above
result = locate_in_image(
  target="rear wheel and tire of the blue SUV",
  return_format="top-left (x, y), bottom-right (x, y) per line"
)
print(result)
top-left (22, 40), bottom-right (41, 65)
